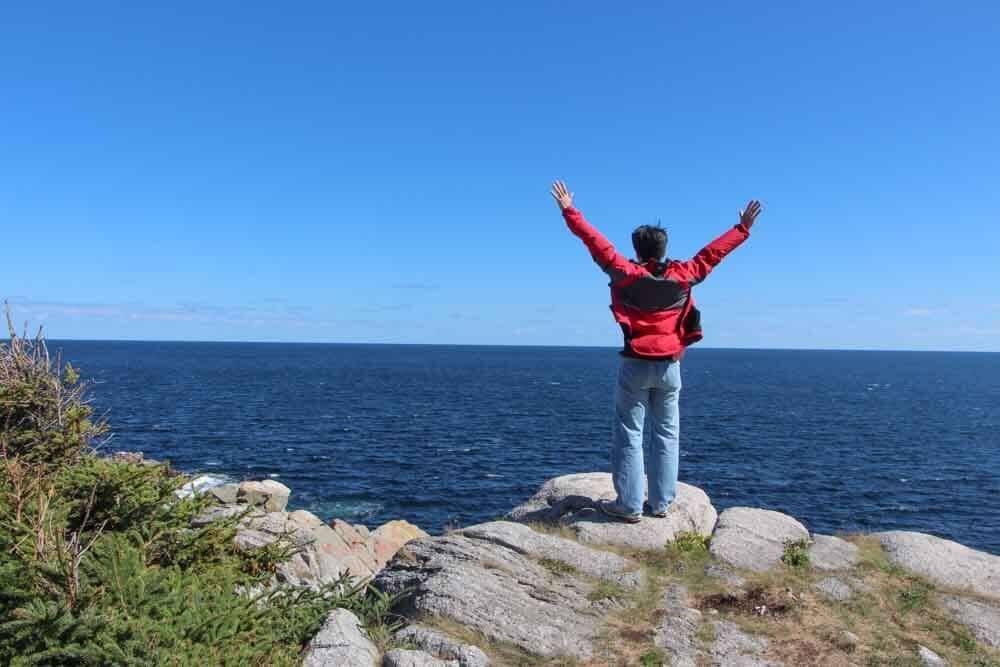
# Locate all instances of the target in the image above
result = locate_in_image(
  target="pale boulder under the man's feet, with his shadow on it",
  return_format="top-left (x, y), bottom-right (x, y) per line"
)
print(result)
top-left (507, 473), bottom-right (718, 550)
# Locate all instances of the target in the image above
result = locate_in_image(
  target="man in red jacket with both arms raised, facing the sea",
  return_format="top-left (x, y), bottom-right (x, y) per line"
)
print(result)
top-left (552, 181), bottom-right (761, 523)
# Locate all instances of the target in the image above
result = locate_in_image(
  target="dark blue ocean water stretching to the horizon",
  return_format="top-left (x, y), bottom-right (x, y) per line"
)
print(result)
top-left (50, 341), bottom-right (1000, 553)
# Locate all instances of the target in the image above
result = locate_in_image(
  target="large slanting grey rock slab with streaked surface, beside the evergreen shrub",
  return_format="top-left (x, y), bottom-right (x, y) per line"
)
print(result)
top-left (375, 521), bottom-right (641, 658)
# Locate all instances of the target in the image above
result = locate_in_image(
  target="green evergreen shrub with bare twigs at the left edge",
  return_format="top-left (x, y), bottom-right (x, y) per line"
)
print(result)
top-left (0, 314), bottom-right (396, 666)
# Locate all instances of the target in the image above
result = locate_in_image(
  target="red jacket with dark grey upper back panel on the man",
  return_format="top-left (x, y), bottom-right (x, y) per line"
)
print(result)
top-left (563, 208), bottom-right (750, 359)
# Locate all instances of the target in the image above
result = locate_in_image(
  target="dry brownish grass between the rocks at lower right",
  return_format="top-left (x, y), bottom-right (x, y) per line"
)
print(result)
top-left (400, 526), bottom-right (1000, 667)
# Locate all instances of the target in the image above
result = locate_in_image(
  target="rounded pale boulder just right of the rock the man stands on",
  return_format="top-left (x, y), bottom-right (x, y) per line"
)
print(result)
top-left (710, 507), bottom-right (809, 572)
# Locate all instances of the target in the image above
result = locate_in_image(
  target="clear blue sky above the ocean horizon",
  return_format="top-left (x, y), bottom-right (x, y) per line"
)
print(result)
top-left (0, 1), bottom-right (1000, 351)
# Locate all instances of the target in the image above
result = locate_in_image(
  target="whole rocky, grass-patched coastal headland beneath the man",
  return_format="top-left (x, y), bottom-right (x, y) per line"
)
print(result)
top-left (199, 473), bottom-right (1000, 667)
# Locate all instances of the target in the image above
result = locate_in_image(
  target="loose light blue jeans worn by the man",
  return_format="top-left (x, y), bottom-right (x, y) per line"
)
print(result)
top-left (611, 357), bottom-right (681, 514)
